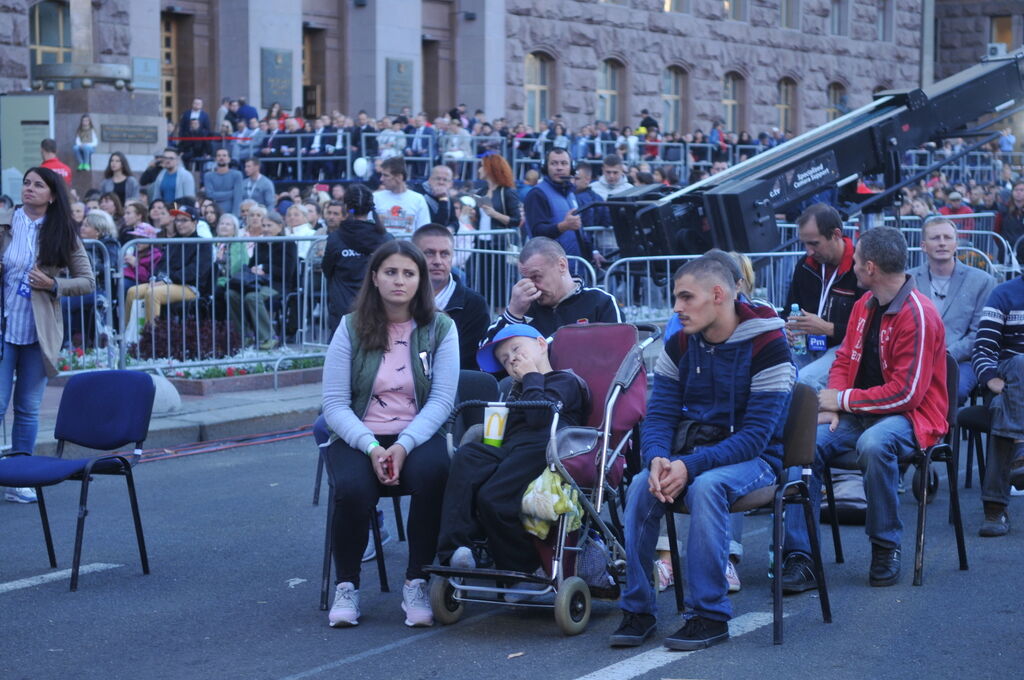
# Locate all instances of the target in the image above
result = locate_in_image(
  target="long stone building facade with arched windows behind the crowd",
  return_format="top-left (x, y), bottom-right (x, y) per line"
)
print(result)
top-left (0, 0), bottom-right (933, 179)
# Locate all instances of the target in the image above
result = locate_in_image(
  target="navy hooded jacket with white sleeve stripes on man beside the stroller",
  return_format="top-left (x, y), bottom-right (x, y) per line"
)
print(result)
top-left (640, 300), bottom-right (797, 480)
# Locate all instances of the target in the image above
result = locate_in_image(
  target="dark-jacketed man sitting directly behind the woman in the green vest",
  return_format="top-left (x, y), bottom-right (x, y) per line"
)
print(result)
top-left (413, 223), bottom-right (490, 371)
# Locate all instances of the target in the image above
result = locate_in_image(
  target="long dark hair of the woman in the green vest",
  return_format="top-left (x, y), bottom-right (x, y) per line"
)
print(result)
top-left (354, 239), bottom-right (435, 351)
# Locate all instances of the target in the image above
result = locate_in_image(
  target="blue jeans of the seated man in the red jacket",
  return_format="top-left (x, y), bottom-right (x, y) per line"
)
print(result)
top-left (783, 413), bottom-right (915, 555)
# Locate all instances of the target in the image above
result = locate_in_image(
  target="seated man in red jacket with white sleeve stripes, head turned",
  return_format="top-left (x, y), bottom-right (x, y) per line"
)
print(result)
top-left (782, 227), bottom-right (947, 593)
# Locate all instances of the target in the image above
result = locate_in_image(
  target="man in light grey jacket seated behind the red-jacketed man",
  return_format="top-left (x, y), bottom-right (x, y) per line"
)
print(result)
top-left (908, 215), bottom-right (995, 403)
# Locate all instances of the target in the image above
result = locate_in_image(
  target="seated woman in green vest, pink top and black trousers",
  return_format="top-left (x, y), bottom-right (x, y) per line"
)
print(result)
top-left (324, 240), bottom-right (459, 627)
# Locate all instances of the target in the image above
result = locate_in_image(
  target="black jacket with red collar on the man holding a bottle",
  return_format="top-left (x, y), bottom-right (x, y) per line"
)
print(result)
top-left (782, 237), bottom-right (864, 347)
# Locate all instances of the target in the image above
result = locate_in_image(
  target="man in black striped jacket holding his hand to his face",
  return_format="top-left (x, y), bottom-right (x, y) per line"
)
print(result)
top-left (484, 237), bottom-right (623, 350)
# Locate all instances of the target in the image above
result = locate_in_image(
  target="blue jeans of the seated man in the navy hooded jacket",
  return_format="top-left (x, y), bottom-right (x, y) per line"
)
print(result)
top-left (620, 458), bottom-right (775, 621)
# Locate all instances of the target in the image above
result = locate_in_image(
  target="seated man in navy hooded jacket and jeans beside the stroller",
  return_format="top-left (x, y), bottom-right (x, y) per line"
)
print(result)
top-left (610, 256), bottom-right (796, 650)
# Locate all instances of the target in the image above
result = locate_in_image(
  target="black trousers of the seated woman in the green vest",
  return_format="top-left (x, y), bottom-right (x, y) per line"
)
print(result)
top-left (326, 434), bottom-right (449, 588)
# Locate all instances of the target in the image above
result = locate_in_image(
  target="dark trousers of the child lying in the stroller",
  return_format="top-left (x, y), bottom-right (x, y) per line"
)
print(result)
top-left (437, 432), bottom-right (547, 573)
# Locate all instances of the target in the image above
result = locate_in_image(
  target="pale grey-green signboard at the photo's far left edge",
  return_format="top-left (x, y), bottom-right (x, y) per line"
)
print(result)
top-left (0, 94), bottom-right (54, 196)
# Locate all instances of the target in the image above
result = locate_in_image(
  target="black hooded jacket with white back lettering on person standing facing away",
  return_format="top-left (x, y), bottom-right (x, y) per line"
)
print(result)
top-left (321, 219), bottom-right (393, 335)
